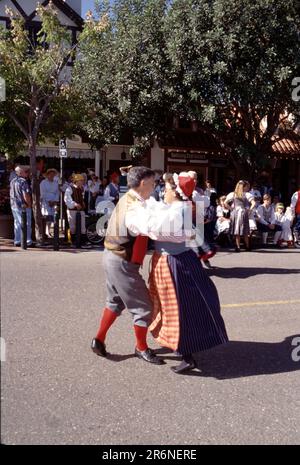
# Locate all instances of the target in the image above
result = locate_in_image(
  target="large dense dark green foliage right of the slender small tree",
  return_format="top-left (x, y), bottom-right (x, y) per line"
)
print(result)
top-left (76, 0), bottom-right (300, 175)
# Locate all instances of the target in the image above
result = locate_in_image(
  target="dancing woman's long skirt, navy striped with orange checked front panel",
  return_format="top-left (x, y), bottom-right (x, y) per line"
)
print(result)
top-left (149, 250), bottom-right (228, 355)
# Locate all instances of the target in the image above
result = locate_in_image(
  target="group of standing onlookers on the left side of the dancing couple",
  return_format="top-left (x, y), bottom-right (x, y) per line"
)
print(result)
top-left (9, 159), bottom-right (126, 247)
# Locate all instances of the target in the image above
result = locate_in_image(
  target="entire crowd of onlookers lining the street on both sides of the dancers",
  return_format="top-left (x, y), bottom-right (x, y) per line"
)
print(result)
top-left (5, 161), bottom-right (300, 252)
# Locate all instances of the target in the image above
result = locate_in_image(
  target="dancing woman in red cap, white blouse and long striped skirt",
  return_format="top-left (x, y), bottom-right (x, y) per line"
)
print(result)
top-left (130, 173), bottom-right (228, 373)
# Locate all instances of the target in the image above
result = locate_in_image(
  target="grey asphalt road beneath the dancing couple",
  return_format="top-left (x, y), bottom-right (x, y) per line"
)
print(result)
top-left (0, 248), bottom-right (300, 445)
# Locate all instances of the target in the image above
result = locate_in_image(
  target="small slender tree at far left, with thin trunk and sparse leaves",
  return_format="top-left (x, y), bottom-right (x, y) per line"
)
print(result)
top-left (0, 2), bottom-right (75, 240)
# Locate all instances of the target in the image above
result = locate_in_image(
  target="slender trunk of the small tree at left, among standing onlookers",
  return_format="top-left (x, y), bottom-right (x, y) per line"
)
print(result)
top-left (29, 138), bottom-right (45, 242)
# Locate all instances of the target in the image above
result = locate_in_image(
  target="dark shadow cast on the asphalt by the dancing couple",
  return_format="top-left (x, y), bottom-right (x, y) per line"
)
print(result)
top-left (178, 335), bottom-right (300, 379)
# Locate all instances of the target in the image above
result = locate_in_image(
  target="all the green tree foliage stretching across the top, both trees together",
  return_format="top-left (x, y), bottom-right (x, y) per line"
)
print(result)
top-left (0, 0), bottom-right (300, 179)
